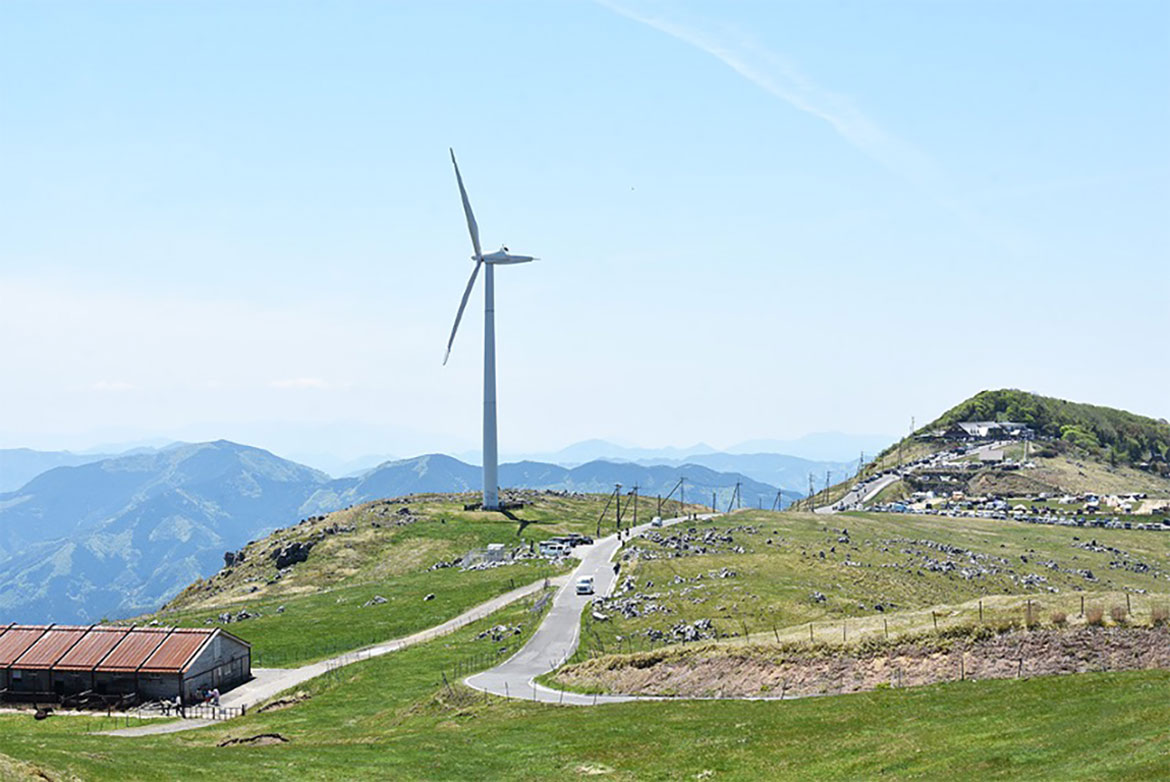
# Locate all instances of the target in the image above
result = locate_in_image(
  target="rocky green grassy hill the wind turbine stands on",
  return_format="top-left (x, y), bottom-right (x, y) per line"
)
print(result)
top-left (138, 491), bottom-right (703, 667)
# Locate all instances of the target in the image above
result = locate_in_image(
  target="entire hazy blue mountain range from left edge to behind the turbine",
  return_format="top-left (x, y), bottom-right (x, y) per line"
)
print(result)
top-left (0, 440), bottom-right (800, 622)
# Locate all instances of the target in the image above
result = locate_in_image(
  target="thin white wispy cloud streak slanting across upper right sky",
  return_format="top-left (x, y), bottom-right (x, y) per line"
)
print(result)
top-left (593, 0), bottom-right (1020, 254)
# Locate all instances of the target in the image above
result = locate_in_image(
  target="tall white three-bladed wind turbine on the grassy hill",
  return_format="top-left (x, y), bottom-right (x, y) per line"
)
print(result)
top-left (442, 150), bottom-right (536, 510)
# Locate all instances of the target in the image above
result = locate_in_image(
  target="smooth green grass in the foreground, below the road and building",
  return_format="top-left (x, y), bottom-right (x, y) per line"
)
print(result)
top-left (0, 606), bottom-right (1170, 782)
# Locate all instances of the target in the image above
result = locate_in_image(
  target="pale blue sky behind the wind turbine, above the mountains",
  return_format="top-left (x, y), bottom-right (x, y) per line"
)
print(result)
top-left (0, 0), bottom-right (1170, 455)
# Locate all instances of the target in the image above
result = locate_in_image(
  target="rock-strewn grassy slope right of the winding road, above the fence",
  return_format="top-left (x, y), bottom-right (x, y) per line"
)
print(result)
top-left (581, 510), bottom-right (1170, 654)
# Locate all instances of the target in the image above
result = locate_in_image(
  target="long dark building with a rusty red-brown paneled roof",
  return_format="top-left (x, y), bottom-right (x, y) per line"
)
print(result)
top-left (0, 624), bottom-right (252, 704)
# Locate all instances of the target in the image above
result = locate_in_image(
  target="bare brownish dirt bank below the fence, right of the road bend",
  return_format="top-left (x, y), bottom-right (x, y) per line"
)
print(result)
top-left (557, 627), bottom-right (1170, 698)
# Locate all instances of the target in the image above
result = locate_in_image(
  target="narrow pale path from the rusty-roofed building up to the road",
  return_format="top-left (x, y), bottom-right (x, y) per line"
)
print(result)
top-left (102, 576), bottom-right (569, 736)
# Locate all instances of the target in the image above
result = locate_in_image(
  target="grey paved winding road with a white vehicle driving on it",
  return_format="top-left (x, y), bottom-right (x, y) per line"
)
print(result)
top-left (463, 514), bottom-right (715, 706)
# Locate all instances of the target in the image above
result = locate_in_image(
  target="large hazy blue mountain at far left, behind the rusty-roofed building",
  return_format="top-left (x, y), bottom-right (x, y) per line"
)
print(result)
top-left (0, 441), bottom-right (329, 622)
